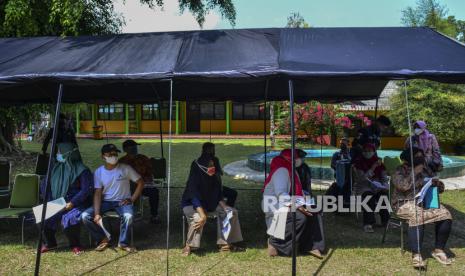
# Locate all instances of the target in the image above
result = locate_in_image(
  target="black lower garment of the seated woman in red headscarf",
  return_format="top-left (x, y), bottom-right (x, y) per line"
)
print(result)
top-left (270, 211), bottom-right (323, 256)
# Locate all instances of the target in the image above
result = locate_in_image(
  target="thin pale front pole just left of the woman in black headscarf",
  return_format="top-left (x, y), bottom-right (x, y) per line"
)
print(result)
top-left (166, 80), bottom-right (173, 275)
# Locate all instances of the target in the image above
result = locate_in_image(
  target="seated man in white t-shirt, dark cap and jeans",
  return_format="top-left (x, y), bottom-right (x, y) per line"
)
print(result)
top-left (81, 144), bottom-right (144, 252)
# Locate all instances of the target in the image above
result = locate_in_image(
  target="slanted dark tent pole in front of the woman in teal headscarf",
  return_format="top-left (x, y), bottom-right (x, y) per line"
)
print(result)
top-left (34, 83), bottom-right (63, 276)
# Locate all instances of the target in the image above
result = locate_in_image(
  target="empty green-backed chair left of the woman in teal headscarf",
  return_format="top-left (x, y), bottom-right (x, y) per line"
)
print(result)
top-left (0, 174), bottom-right (39, 244)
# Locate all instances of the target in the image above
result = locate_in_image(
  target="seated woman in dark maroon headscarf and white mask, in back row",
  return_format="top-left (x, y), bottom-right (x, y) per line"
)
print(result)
top-left (354, 143), bottom-right (389, 233)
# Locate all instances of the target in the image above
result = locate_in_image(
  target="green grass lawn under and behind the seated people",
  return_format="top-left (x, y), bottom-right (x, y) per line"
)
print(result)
top-left (0, 140), bottom-right (465, 275)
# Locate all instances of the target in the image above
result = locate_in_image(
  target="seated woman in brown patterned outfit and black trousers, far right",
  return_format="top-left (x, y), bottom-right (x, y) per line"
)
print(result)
top-left (392, 148), bottom-right (452, 268)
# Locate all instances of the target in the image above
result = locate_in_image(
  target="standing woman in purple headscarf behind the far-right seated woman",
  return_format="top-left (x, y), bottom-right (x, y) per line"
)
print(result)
top-left (405, 121), bottom-right (443, 173)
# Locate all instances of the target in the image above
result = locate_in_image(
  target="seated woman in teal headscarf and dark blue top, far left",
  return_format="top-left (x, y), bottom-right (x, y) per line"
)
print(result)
top-left (41, 143), bottom-right (94, 255)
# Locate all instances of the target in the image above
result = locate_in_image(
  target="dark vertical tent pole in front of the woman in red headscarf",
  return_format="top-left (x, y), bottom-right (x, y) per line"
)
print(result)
top-left (289, 80), bottom-right (297, 276)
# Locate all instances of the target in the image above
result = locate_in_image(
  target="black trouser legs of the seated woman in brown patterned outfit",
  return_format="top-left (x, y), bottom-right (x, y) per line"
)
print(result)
top-left (408, 219), bottom-right (452, 254)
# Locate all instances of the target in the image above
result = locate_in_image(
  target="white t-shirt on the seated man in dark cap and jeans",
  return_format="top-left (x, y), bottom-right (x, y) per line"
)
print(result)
top-left (94, 164), bottom-right (141, 201)
